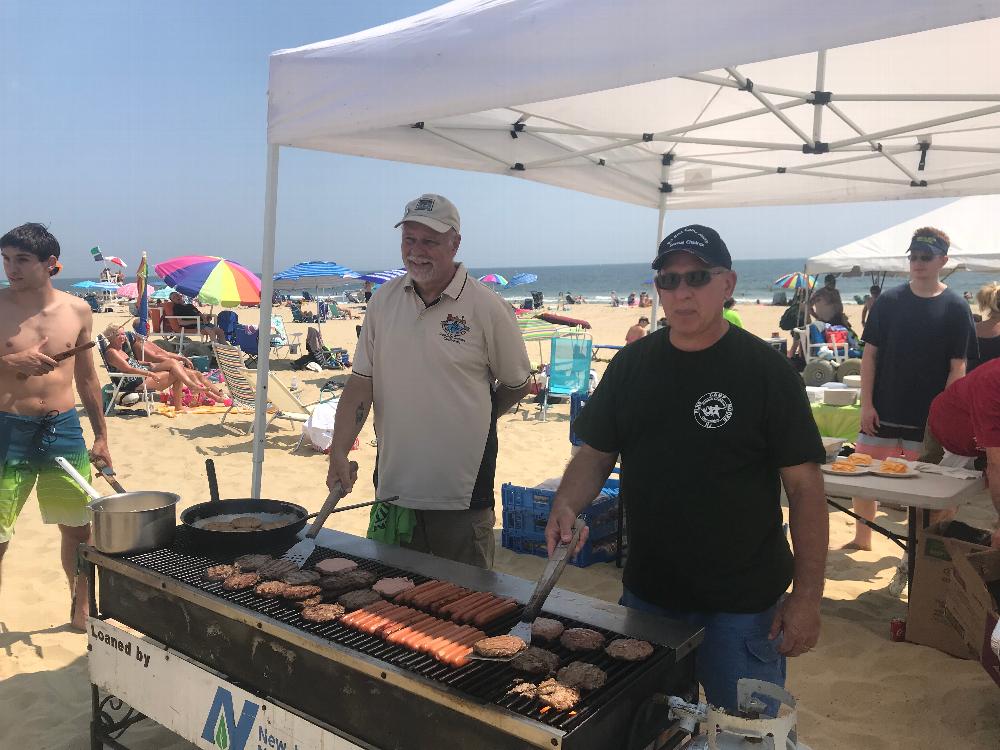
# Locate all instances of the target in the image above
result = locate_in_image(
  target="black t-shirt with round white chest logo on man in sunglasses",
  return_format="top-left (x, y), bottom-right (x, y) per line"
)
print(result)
top-left (573, 326), bottom-right (825, 612)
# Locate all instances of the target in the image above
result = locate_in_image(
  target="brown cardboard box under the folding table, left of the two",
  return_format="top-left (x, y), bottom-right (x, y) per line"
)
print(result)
top-left (906, 524), bottom-right (989, 659)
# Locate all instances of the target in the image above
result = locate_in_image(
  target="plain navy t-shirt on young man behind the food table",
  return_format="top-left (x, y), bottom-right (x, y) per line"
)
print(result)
top-left (862, 284), bottom-right (979, 430)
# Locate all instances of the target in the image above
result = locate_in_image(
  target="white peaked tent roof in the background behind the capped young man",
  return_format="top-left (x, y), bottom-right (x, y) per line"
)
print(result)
top-left (806, 195), bottom-right (1000, 274)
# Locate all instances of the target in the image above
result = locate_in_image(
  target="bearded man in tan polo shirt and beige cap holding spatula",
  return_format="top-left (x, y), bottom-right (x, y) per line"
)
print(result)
top-left (327, 194), bottom-right (530, 568)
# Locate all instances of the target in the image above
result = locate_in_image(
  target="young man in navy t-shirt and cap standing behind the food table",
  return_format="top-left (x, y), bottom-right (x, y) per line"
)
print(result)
top-left (844, 227), bottom-right (976, 550)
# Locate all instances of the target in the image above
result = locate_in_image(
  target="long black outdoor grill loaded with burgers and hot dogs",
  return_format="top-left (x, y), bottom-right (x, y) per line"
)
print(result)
top-left (84, 530), bottom-right (701, 750)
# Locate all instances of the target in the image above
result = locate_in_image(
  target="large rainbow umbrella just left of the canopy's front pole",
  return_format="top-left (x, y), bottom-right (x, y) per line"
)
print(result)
top-left (155, 255), bottom-right (260, 307)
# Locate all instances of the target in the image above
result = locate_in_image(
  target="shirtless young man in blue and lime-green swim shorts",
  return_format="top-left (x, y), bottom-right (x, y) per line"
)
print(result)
top-left (0, 224), bottom-right (111, 629)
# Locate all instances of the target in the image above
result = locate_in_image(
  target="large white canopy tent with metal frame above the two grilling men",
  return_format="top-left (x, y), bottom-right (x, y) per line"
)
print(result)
top-left (252, 0), bottom-right (1000, 497)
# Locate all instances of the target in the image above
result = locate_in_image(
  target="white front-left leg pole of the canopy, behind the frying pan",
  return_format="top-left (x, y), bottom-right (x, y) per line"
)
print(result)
top-left (250, 143), bottom-right (279, 498)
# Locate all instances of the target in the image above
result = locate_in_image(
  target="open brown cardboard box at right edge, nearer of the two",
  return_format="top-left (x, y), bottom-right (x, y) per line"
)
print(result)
top-left (946, 549), bottom-right (1000, 686)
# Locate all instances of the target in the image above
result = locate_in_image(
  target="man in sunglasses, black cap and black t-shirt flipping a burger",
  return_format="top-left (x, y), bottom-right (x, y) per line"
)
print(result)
top-left (545, 225), bottom-right (828, 710)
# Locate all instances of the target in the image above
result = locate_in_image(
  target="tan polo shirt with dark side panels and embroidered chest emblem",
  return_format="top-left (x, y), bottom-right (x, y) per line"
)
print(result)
top-left (354, 264), bottom-right (531, 510)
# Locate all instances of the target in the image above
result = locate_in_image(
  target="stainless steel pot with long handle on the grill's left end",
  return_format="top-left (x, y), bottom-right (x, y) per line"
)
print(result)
top-left (56, 457), bottom-right (181, 555)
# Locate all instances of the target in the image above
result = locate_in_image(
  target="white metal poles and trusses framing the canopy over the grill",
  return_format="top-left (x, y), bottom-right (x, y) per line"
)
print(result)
top-left (251, 50), bottom-right (1000, 497)
